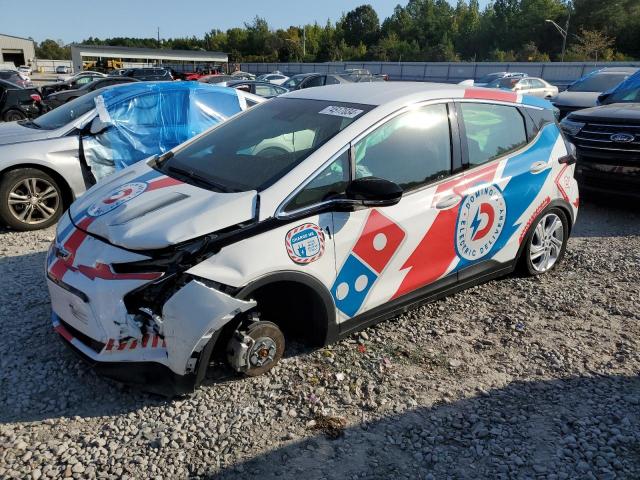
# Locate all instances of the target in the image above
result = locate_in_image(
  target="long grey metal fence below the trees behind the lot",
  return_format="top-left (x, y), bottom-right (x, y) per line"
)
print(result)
top-left (240, 62), bottom-right (640, 86)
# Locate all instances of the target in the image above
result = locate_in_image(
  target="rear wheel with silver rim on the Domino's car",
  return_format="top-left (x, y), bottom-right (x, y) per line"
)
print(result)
top-left (521, 208), bottom-right (569, 275)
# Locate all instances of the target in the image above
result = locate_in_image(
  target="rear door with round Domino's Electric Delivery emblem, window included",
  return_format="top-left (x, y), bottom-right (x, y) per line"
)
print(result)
top-left (455, 101), bottom-right (557, 274)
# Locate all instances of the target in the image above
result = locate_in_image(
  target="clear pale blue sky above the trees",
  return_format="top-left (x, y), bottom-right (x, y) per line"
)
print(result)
top-left (0, 0), bottom-right (488, 43)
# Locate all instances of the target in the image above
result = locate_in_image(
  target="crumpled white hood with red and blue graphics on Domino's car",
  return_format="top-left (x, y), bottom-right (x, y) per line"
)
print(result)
top-left (69, 162), bottom-right (257, 250)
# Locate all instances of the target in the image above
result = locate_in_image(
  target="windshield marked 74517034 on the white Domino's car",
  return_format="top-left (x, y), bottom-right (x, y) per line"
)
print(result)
top-left (162, 98), bottom-right (373, 192)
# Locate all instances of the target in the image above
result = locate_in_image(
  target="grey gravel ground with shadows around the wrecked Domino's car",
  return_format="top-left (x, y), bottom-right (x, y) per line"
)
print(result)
top-left (0, 197), bottom-right (640, 479)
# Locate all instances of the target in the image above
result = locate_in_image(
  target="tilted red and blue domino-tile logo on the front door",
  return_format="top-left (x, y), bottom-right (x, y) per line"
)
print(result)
top-left (331, 210), bottom-right (406, 317)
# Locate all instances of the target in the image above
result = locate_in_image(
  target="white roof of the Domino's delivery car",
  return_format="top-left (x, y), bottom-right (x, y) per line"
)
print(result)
top-left (283, 82), bottom-right (467, 105)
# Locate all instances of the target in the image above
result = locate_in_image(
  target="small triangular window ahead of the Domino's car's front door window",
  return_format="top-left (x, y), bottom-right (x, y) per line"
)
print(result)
top-left (285, 150), bottom-right (349, 212)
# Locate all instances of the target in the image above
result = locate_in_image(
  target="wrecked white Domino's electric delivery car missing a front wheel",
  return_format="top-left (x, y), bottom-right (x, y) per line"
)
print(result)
top-left (46, 82), bottom-right (578, 394)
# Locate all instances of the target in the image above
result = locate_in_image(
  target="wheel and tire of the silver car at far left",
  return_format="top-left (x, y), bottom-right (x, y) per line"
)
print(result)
top-left (0, 168), bottom-right (64, 231)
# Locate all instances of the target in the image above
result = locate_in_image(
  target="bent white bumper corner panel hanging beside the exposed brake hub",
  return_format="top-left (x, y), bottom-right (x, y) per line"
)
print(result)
top-left (162, 280), bottom-right (256, 375)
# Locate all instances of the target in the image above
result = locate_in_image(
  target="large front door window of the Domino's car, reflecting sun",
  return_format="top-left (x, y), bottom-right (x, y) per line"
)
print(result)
top-left (355, 104), bottom-right (451, 191)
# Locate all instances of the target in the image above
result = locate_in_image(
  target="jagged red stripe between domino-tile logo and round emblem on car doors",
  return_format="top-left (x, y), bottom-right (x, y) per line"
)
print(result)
top-left (392, 163), bottom-right (498, 298)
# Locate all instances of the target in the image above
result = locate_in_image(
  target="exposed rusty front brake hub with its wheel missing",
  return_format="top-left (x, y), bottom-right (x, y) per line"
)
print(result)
top-left (227, 321), bottom-right (285, 377)
